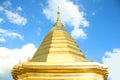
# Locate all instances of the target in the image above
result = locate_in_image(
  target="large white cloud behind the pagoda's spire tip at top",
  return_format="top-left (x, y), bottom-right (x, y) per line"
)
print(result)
top-left (43, 0), bottom-right (89, 38)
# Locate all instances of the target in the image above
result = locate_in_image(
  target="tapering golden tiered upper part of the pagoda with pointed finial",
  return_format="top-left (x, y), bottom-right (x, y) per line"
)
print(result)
top-left (31, 7), bottom-right (87, 63)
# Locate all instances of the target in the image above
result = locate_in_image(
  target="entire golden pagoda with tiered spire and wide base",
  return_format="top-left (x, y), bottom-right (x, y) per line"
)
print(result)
top-left (11, 9), bottom-right (108, 80)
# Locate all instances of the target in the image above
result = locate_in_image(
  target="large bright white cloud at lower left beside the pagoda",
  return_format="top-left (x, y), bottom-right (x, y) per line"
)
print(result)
top-left (0, 43), bottom-right (36, 80)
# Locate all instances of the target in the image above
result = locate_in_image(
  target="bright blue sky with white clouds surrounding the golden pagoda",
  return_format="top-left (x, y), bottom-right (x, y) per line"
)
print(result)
top-left (0, 0), bottom-right (120, 80)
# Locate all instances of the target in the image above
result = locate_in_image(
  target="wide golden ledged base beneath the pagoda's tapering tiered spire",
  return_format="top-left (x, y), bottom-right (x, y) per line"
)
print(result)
top-left (12, 62), bottom-right (108, 80)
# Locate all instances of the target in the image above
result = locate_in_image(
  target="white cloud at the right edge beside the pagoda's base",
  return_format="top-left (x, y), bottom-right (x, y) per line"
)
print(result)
top-left (103, 48), bottom-right (120, 80)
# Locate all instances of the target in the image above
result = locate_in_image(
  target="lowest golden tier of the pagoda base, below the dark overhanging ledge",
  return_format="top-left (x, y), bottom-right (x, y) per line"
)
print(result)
top-left (18, 73), bottom-right (104, 80)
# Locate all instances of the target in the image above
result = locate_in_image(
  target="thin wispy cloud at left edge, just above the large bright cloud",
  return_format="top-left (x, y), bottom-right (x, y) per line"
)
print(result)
top-left (0, 28), bottom-right (24, 42)
